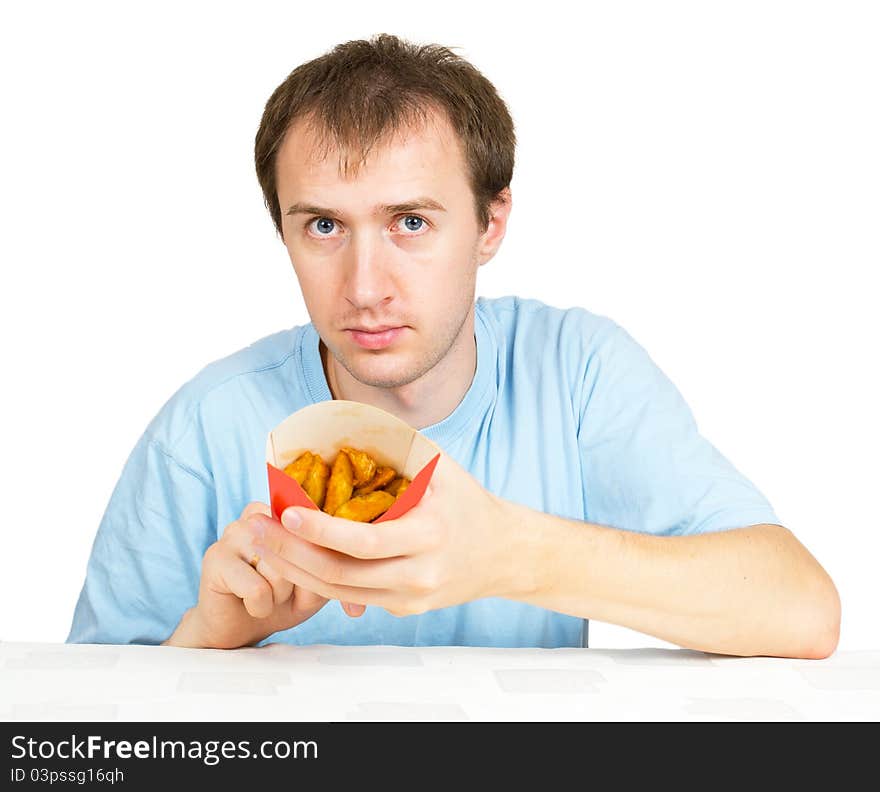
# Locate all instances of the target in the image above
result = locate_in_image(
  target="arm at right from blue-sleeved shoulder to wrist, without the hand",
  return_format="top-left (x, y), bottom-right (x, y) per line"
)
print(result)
top-left (560, 324), bottom-right (840, 658)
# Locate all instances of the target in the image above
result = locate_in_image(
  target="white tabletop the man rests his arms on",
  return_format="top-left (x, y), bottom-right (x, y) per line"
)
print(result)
top-left (0, 643), bottom-right (880, 722)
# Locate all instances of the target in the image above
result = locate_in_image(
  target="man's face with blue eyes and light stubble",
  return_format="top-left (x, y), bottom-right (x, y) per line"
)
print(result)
top-left (277, 109), bottom-right (503, 388)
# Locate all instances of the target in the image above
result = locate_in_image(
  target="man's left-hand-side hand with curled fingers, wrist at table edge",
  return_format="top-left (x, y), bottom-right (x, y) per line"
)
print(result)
top-left (164, 503), bottom-right (327, 649)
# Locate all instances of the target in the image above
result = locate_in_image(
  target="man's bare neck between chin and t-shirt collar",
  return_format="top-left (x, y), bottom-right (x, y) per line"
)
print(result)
top-left (319, 310), bottom-right (477, 429)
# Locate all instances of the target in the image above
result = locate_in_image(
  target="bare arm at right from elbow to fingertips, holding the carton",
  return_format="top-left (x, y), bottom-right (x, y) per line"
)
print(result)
top-left (246, 446), bottom-right (840, 659)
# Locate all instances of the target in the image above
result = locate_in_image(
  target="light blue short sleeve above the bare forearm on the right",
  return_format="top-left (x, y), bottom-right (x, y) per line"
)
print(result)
top-left (578, 322), bottom-right (779, 535)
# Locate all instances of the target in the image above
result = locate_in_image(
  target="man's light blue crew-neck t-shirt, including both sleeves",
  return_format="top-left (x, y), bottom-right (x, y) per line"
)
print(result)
top-left (67, 297), bottom-right (779, 647)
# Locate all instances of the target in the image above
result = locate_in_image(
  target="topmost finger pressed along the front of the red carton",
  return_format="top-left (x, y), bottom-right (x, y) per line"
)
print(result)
top-left (281, 506), bottom-right (431, 558)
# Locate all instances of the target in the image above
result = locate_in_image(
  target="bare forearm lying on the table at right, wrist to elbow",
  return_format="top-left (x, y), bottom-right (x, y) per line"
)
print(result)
top-left (504, 502), bottom-right (840, 658)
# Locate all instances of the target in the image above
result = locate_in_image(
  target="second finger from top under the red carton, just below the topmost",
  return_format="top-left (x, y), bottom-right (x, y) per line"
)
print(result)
top-left (257, 522), bottom-right (413, 602)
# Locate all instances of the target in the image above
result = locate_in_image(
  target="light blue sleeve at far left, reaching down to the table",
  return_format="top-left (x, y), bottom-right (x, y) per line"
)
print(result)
top-left (67, 434), bottom-right (216, 644)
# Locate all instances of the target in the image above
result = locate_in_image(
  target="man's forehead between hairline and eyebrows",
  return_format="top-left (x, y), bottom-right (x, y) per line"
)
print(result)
top-left (276, 113), bottom-right (470, 206)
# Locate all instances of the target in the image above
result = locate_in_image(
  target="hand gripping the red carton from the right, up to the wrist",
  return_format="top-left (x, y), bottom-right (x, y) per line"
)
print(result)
top-left (248, 454), bottom-right (527, 616)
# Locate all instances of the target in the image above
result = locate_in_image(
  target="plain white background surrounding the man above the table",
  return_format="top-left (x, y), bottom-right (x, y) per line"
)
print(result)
top-left (0, 0), bottom-right (880, 649)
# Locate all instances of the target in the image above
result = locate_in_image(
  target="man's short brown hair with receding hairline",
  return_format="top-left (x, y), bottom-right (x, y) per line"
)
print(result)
top-left (254, 34), bottom-right (516, 237)
